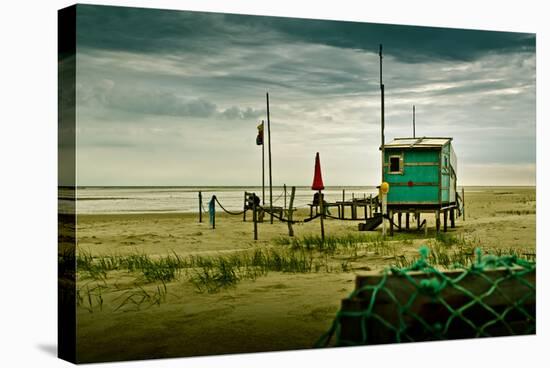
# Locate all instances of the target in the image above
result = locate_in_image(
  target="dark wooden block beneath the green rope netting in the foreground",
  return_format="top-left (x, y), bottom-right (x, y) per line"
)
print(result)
top-left (340, 267), bottom-right (536, 344)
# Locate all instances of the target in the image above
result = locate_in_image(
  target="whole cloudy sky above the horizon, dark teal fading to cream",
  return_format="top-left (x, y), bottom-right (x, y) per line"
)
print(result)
top-left (76, 5), bottom-right (536, 186)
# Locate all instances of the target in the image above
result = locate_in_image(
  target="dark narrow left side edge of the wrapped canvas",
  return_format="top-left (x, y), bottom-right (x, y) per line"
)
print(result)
top-left (57, 6), bottom-right (76, 363)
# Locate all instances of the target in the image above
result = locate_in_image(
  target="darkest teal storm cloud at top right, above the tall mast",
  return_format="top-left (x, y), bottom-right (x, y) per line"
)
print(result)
top-left (260, 18), bottom-right (535, 63)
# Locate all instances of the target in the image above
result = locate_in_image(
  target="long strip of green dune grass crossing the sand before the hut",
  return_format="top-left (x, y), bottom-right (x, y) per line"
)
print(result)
top-left (71, 233), bottom-right (535, 312)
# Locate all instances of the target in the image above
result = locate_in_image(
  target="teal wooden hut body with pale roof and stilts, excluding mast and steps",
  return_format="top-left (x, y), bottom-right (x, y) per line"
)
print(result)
top-left (383, 137), bottom-right (460, 234)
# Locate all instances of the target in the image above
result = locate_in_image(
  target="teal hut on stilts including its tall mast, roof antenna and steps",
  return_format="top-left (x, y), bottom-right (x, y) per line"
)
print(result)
top-left (359, 45), bottom-right (464, 235)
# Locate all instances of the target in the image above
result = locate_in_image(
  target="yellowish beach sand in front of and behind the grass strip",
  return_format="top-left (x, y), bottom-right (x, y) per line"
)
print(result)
top-left (68, 187), bottom-right (536, 362)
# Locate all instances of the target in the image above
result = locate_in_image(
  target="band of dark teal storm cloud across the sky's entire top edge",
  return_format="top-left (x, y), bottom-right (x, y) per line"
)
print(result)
top-left (77, 5), bottom-right (535, 63)
